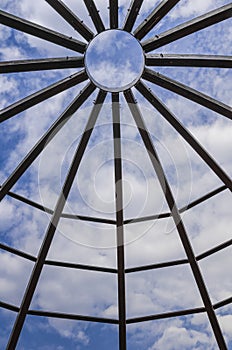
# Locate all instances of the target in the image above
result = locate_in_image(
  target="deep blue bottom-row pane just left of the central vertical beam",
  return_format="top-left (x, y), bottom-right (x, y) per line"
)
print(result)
top-left (17, 316), bottom-right (118, 350)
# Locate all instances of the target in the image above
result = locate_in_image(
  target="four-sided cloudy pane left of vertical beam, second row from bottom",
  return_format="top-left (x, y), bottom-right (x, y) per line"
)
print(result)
top-left (31, 266), bottom-right (117, 318)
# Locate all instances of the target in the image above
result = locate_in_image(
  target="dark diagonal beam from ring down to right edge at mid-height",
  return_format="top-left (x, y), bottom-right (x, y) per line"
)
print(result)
top-left (136, 82), bottom-right (232, 191)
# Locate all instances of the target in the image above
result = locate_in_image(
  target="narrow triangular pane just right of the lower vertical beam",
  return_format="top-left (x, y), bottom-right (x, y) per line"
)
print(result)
top-left (121, 95), bottom-right (169, 219)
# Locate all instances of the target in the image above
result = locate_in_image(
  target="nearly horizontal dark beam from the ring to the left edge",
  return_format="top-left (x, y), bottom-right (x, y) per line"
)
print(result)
top-left (0, 57), bottom-right (84, 74)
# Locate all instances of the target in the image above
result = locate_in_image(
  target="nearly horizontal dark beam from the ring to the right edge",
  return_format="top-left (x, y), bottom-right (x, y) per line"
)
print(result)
top-left (145, 54), bottom-right (232, 68)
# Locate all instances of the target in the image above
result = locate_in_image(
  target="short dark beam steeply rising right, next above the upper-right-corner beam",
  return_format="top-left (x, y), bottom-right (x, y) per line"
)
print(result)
top-left (134, 0), bottom-right (180, 40)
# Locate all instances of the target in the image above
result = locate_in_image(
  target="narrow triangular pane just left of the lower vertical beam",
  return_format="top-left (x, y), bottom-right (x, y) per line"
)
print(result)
top-left (64, 95), bottom-right (115, 220)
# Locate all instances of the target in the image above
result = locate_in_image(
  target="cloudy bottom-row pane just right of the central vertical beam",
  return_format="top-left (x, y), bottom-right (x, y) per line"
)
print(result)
top-left (128, 313), bottom-right (218, 350)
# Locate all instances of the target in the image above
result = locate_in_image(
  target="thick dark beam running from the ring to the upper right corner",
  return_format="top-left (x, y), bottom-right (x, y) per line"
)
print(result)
top-left (142, 4), bottom-right (232, 52)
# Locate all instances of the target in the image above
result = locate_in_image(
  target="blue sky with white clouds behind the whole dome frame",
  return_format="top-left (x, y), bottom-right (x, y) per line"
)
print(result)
top-left (0, 0), bottom-right (232, 350)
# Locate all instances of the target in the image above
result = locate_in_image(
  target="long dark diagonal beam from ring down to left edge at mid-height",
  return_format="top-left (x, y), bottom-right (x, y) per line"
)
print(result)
top-left (0, 83), bottom-right (95, 201)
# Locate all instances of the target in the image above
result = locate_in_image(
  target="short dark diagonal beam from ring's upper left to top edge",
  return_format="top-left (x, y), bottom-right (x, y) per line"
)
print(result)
top-left (45, 0), bottom-right (93, 41)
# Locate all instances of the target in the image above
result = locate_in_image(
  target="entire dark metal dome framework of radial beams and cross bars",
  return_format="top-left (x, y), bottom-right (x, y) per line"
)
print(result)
top-left (0, 0), bottom-right (232, 350)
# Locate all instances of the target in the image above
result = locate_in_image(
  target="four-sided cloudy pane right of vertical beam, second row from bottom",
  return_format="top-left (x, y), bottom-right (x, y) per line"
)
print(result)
top-left (126, 266), bottom-right (202, 318)
